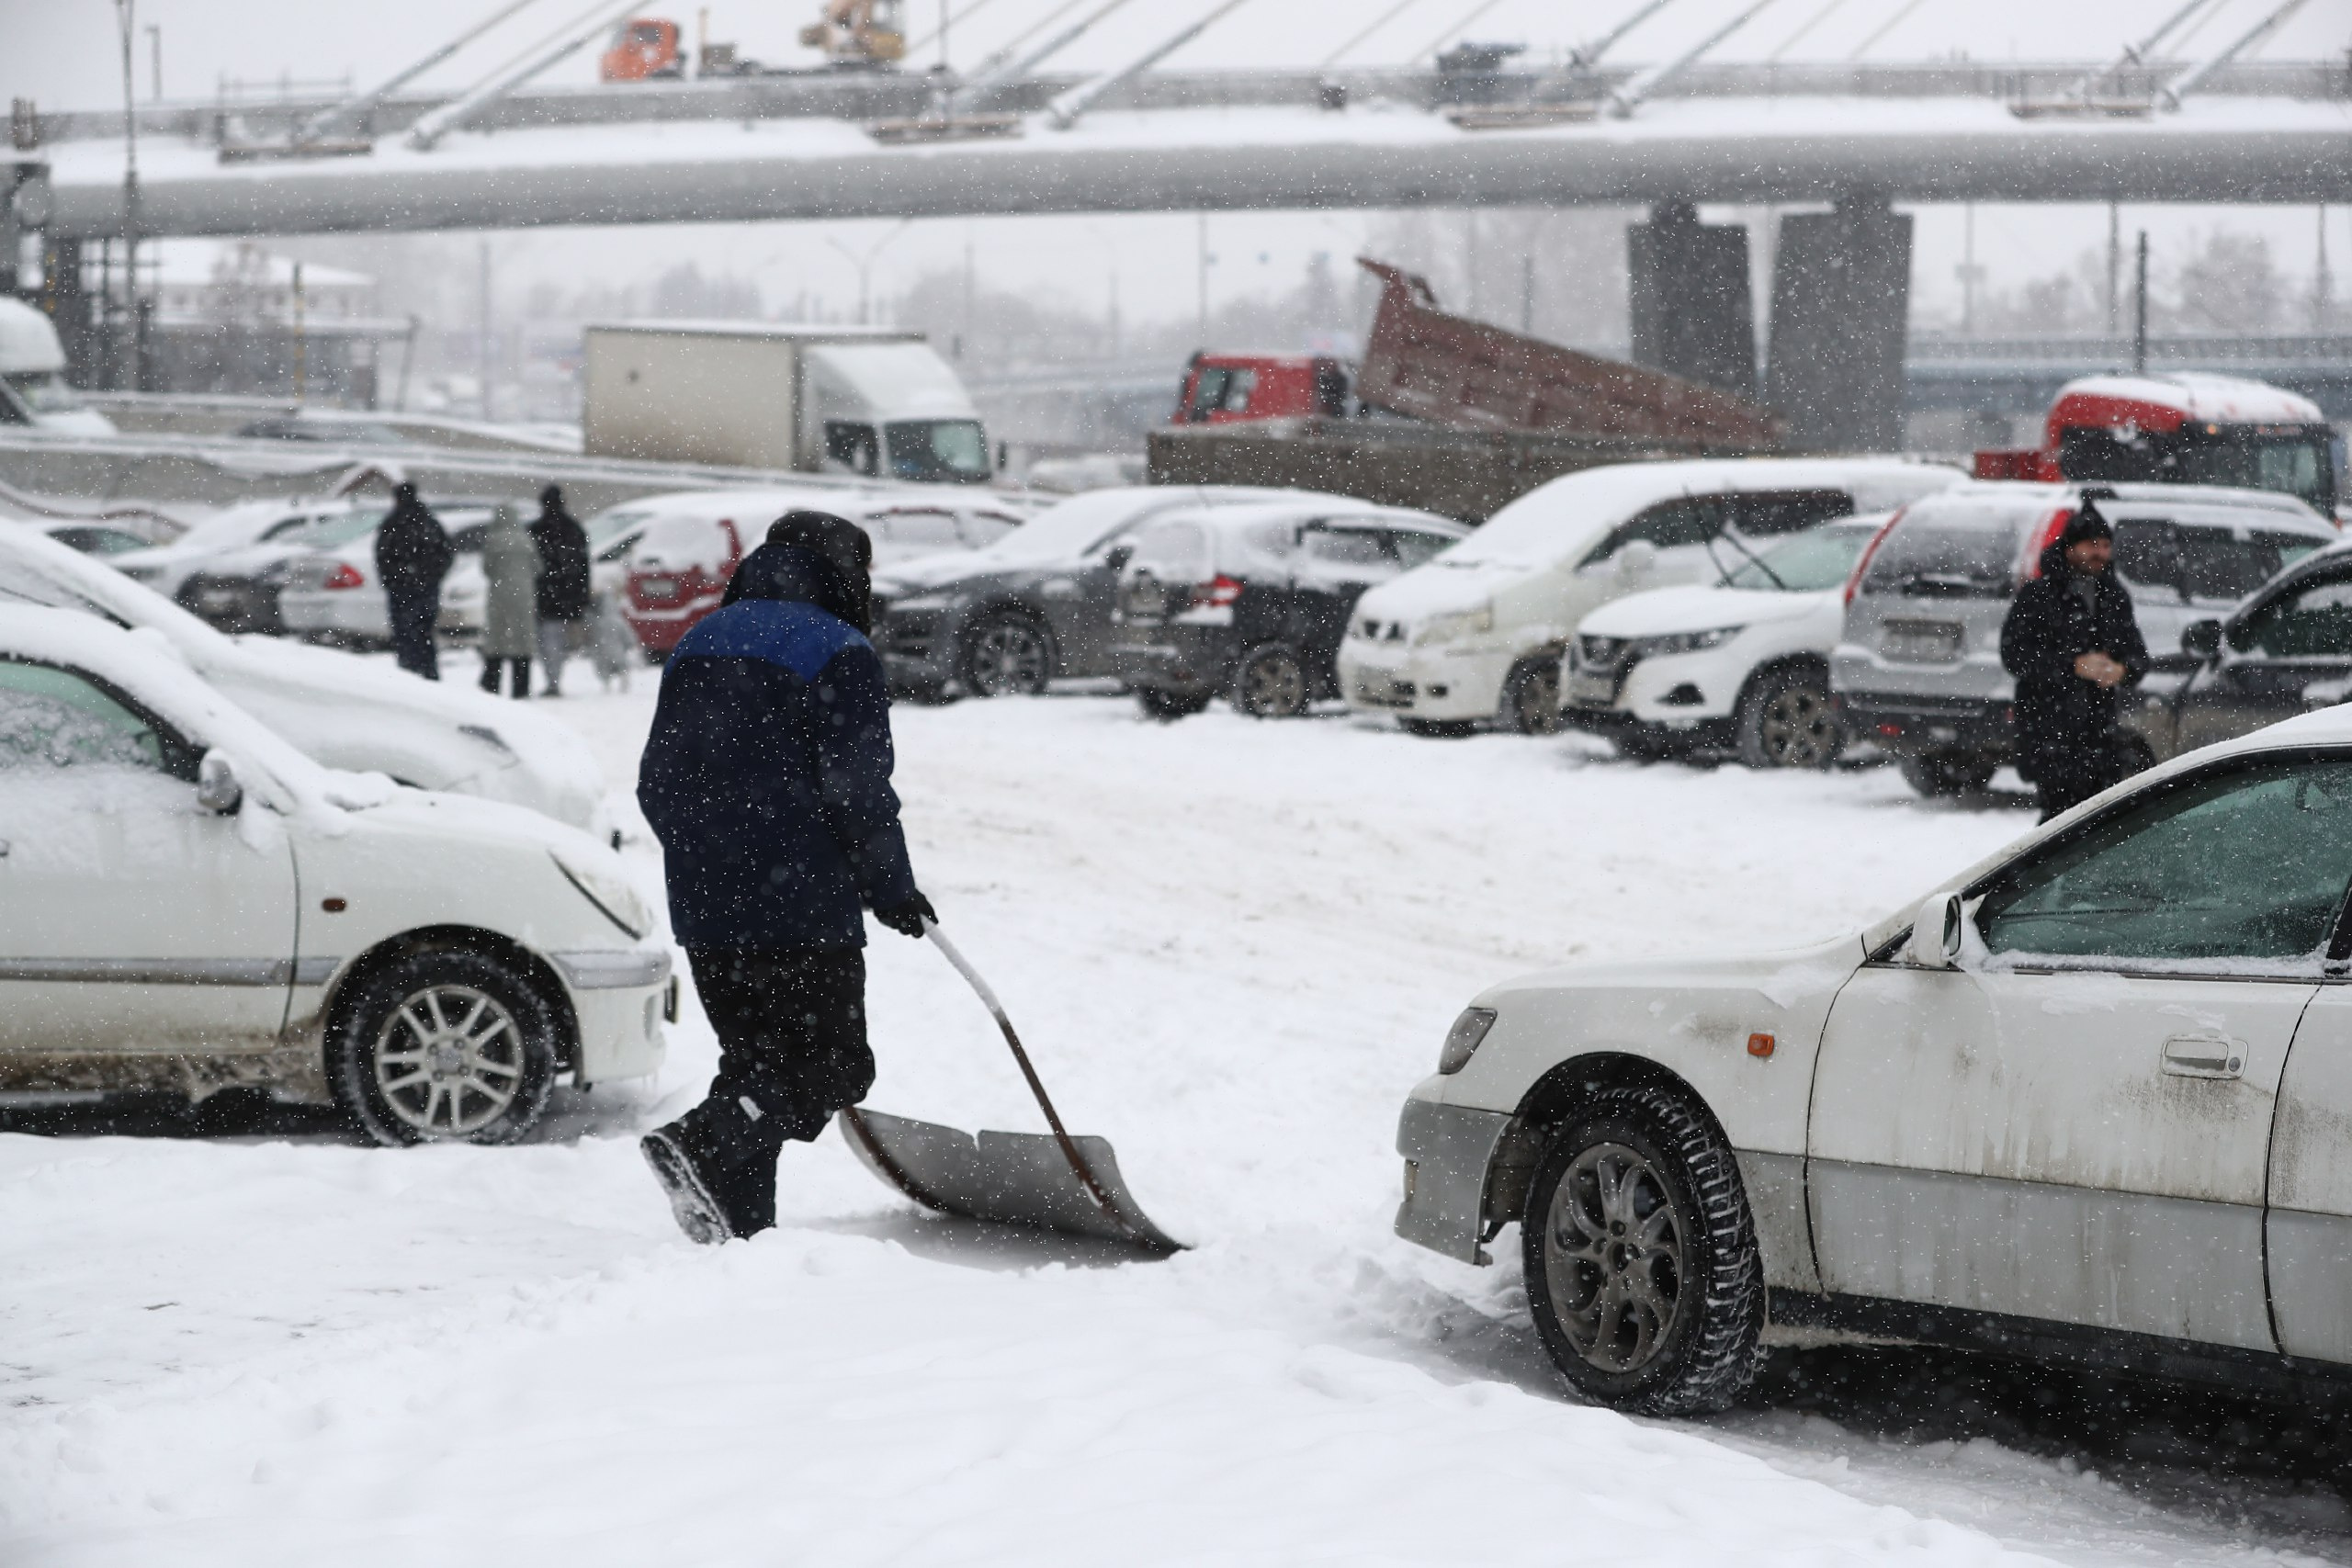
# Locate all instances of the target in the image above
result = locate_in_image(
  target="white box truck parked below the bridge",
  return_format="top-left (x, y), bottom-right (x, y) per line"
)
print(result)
top-left (583, 322), bottom-right (995, 484)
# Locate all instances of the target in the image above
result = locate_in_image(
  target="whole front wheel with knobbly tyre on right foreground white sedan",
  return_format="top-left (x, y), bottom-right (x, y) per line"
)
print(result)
top-left (1520, 1089), bottom-right (1764, 1416)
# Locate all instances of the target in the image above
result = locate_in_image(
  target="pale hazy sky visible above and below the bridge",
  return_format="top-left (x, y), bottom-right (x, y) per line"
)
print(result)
top-left (0, 0), bottom-right (2352, 338)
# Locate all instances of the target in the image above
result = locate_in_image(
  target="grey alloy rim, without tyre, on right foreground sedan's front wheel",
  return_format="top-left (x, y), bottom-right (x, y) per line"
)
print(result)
top-left (1543, 1143), bottom-right (1689, 1373)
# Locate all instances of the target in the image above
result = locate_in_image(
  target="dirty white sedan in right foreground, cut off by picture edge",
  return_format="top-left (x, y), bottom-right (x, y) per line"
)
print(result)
top-left (1397, 707), bottom-right (2352, 1413)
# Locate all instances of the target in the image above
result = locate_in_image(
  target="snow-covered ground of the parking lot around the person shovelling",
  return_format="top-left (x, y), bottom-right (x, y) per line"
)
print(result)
top-left (0, 700), bottom-right (2352, 1568)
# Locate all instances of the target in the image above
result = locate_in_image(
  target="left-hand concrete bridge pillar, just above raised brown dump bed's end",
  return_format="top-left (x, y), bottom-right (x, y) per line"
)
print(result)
top-left (1625, 202), bottom-right (1757, 398)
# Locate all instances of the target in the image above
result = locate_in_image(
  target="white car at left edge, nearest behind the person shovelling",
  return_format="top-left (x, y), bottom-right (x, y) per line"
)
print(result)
top-left (0, 606), bottom-right (673, 1145)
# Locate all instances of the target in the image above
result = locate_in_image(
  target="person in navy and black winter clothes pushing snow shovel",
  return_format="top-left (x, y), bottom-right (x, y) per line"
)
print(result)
top-left (638, 513), bottom-right (933, 1241)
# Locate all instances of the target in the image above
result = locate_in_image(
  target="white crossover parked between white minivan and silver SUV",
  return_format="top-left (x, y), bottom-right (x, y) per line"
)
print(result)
top-left (1559, 513), bottom-right (1886, 769)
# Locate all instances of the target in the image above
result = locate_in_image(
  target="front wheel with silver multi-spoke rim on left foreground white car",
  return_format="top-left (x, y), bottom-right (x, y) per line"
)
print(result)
top-left (327, 950), bottom-right (558, 1147)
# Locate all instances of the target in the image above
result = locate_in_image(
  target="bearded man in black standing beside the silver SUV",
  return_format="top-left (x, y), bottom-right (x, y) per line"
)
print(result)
top-left (2002, 496), bottom-right (2147, 823)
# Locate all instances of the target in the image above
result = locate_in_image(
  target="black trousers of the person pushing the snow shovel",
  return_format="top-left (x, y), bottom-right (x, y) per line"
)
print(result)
top-left (687, 947), bottom-right (875, 1235)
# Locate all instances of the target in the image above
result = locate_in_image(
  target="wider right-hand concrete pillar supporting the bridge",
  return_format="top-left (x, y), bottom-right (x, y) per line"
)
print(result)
top-left (1764, 195), bottom-right (1912, 451)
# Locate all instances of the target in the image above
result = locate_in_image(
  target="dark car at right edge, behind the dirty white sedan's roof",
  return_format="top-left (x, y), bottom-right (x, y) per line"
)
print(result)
top-left (2131, 546), bottom-right (2352, 760)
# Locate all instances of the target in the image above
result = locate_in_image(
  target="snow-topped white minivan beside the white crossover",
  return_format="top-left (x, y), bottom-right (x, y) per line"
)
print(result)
top-left (1339, 458), bottom-right (1964, 733)
